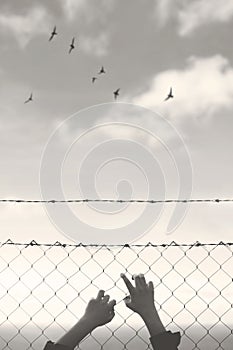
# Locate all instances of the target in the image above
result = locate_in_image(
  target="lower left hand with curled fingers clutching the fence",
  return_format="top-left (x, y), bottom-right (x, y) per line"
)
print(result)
top-left (84, 290), bottom-right (116, 328)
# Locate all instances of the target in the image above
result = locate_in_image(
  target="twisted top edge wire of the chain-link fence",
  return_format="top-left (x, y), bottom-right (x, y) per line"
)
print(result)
top-left (0, 239), bottom-right (233, 248)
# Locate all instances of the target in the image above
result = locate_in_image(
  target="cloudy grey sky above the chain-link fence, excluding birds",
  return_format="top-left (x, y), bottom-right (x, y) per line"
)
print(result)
top-left (0, 0), bottom-right (233, 243)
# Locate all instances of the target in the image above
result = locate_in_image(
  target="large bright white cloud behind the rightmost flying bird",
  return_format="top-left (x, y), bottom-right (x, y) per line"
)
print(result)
top-left (133, 55), bottom-right (233, 119)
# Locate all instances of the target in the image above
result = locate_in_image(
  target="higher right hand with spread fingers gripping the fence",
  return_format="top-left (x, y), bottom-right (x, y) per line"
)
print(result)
top-left (121, 274), bottom-right (156, 317)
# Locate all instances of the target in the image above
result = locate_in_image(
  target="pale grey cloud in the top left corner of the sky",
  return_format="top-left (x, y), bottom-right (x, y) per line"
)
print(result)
top-left (0, 7), bottom-right (50, 48)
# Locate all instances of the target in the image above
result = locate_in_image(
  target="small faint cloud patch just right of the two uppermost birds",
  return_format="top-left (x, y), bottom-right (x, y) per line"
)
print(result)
top-left (80, 33), bottom-right (109, 57)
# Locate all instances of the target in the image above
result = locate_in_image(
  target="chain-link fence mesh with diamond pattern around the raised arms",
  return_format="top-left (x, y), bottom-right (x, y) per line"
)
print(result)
top-left (0, 240), bottom-right (233, 350)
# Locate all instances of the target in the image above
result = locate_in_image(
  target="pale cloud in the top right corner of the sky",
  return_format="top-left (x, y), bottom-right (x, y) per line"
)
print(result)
top-left (156, 0), bottom-right (233, 36)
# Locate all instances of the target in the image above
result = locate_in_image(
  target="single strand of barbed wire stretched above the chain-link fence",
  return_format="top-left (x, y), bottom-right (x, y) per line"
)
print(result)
top-left (0, 198), bottom-right (233, 204)
